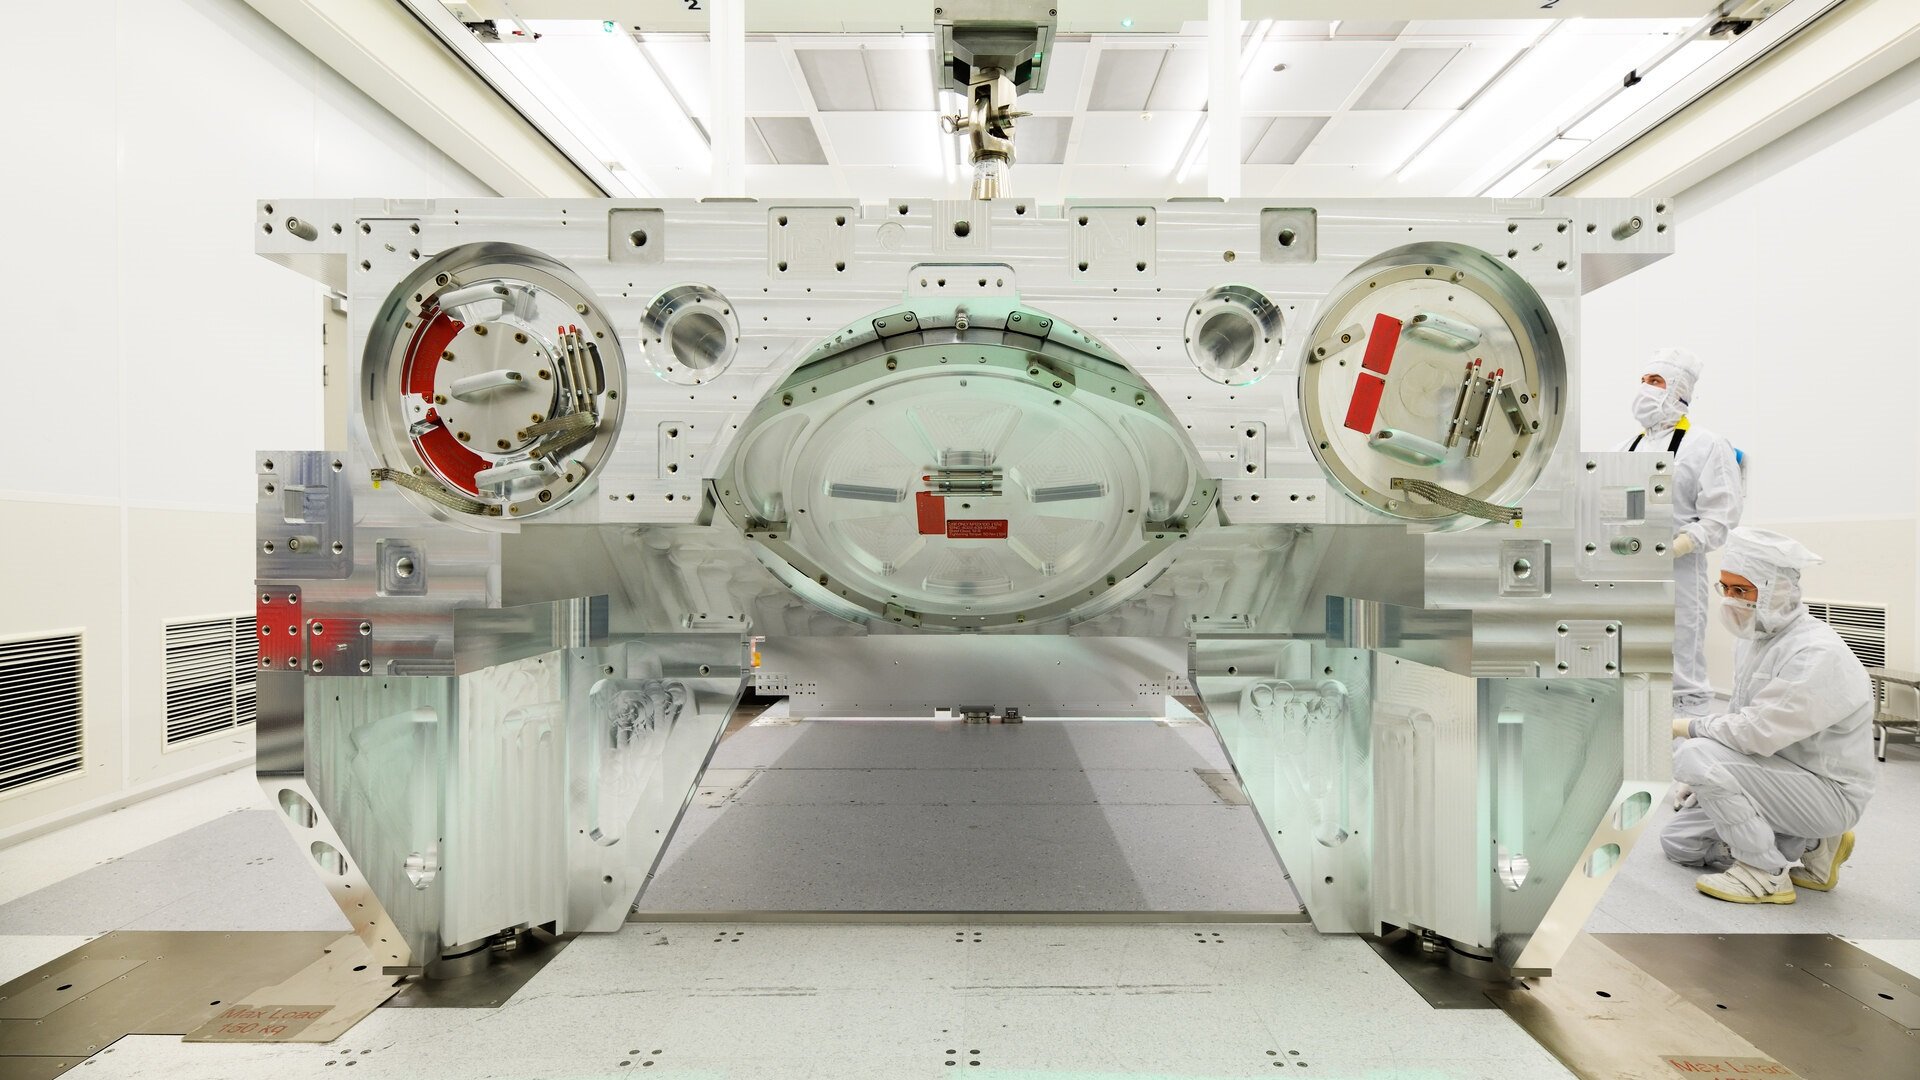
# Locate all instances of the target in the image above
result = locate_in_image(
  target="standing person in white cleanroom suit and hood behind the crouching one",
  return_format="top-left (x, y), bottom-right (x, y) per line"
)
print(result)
top-left (1615, 348), bottom-right (1743, 717)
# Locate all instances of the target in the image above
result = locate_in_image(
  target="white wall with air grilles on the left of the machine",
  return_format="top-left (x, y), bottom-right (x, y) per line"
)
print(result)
top-left (0, 0), bottom-right (492, 842)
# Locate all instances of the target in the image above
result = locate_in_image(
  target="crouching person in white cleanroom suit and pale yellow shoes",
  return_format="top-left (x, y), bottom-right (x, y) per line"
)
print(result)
top-left (1661, 528), bottom-right (1874, 903)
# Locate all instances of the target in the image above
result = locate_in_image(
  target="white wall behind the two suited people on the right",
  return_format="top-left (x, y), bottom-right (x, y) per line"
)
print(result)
top-left (1582, 67), bottom-right (1920, 672)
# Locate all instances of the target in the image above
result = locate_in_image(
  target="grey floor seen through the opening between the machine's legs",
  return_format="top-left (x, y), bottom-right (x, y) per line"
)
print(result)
top-left (639, 721), bottom-right (1300, 911)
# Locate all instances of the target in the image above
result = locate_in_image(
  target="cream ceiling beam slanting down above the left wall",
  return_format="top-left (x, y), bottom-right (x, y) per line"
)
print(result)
top-left (248, 0), bottom-right (605, 198)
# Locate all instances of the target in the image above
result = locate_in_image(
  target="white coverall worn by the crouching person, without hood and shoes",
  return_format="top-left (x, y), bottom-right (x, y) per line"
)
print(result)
top-left (1661, 599), bottom-right (1874, 874)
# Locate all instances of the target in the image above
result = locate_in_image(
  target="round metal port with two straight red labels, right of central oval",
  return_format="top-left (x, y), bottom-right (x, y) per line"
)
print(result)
top-left (1300, 244), bottom-right (1567, 525)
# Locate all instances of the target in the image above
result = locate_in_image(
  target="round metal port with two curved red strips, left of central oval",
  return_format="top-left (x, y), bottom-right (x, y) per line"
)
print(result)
top-left (365, 244), bottom-right (626, 519)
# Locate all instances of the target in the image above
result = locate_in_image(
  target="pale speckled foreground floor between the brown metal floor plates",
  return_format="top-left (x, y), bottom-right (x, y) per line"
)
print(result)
top-left (81, 924), bottom-right (1569, 1080)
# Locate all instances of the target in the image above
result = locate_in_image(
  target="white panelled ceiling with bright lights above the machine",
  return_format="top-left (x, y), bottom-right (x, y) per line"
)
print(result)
top-left (493, 19), bottom-right (1722, 200)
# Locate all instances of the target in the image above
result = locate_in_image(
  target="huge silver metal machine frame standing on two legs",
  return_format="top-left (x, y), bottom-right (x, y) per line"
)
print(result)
top-left (255, 189), bottom-right (1672, 974)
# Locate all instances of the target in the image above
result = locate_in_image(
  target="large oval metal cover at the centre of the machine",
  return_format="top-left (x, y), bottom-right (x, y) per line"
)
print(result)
top-left (714, 302), bottom-right (1215, 630)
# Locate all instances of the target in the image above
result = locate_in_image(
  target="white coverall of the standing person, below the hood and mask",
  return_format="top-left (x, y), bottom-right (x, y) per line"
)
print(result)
top-left (1615, 427), bottom-right (1743, 717)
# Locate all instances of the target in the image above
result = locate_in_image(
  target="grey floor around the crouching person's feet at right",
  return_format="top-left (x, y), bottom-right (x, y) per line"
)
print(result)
top-left (1586, 742), bottom-right (1920, 933)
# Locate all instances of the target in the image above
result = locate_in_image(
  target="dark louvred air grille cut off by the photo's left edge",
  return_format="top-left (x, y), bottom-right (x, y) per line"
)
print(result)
top-left (0, 634), bottom-right (83, 792)
